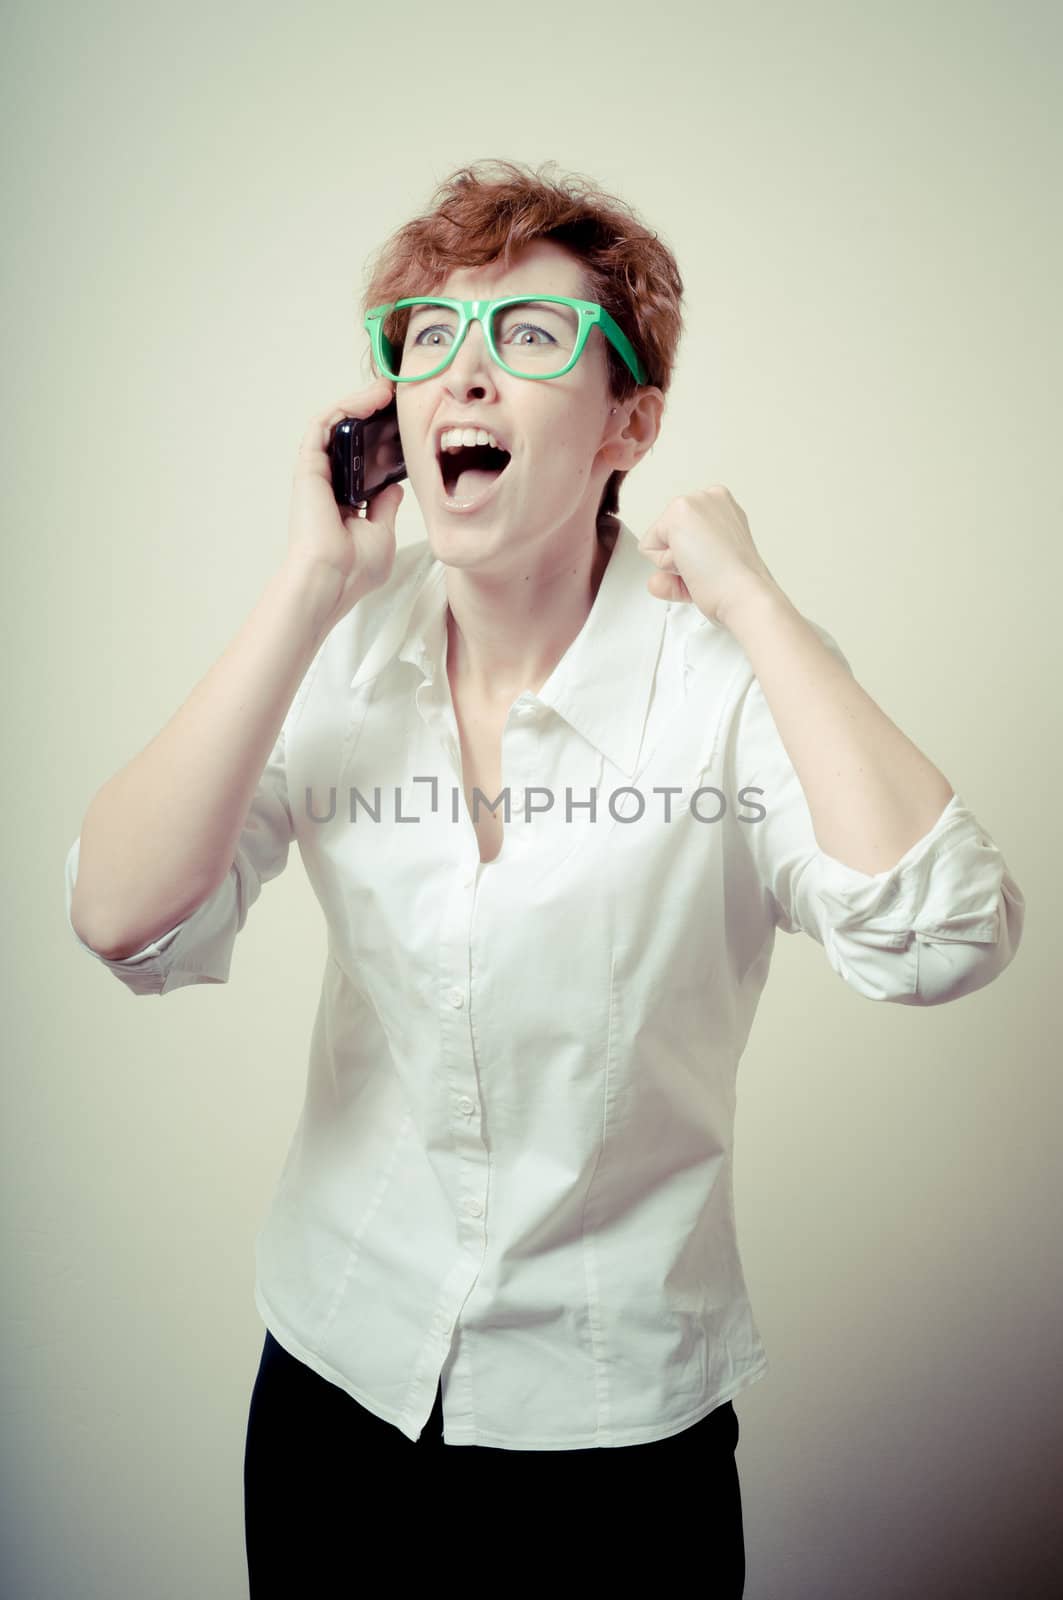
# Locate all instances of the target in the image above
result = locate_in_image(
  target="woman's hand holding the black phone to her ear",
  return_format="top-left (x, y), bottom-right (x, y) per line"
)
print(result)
top-left (287, 378), bottom-right (405, 638)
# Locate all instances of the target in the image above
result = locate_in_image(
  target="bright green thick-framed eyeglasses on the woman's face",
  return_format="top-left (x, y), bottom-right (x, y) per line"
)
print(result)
top-left (365, 294), bottom-right (647, 384)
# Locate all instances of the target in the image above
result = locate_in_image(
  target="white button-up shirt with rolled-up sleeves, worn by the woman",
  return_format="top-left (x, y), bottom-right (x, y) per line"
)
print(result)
top-left (66, 523), bottom-right (1025, 1450)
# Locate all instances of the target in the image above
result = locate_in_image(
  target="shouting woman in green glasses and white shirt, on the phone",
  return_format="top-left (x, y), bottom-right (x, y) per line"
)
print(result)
top-left (67, 163), bottom-right (1025, 1595)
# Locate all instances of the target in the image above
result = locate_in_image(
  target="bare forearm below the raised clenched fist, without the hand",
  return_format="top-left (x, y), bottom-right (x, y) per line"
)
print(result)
top-left (720, 579), bottom-right (954, 874)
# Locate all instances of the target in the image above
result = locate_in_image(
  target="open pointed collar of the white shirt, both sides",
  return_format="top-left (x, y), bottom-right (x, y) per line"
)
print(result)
top-left (351, 522), bottom-right (671, 778)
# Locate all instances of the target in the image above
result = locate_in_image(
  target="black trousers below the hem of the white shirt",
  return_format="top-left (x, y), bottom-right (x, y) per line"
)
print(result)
top-left (243, 1331), bottom-right (746, 1600)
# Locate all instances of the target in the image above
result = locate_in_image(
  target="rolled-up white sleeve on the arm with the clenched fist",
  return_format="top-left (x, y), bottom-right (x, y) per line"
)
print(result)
top-left (733, 624), bottom-right (1026, 1005)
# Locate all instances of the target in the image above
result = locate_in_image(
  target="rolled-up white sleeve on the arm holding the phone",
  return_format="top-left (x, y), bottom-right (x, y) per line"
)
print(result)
top-left (66, 726), bottom-right (295, 995)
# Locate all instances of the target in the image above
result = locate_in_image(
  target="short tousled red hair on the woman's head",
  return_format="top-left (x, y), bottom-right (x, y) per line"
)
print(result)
top-left (362, 160), bottom-right (684, 518)
